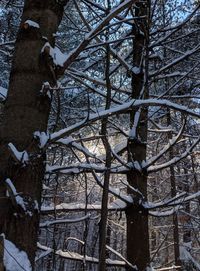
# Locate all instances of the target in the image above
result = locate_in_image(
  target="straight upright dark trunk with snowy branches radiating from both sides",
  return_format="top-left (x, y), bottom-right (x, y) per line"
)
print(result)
top-left (126, 3), bottom-right (150, 271)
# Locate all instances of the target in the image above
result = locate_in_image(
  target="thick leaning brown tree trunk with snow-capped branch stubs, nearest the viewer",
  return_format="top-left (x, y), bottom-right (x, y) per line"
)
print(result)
top-left (0, 0), bottom-right (67, 266)
